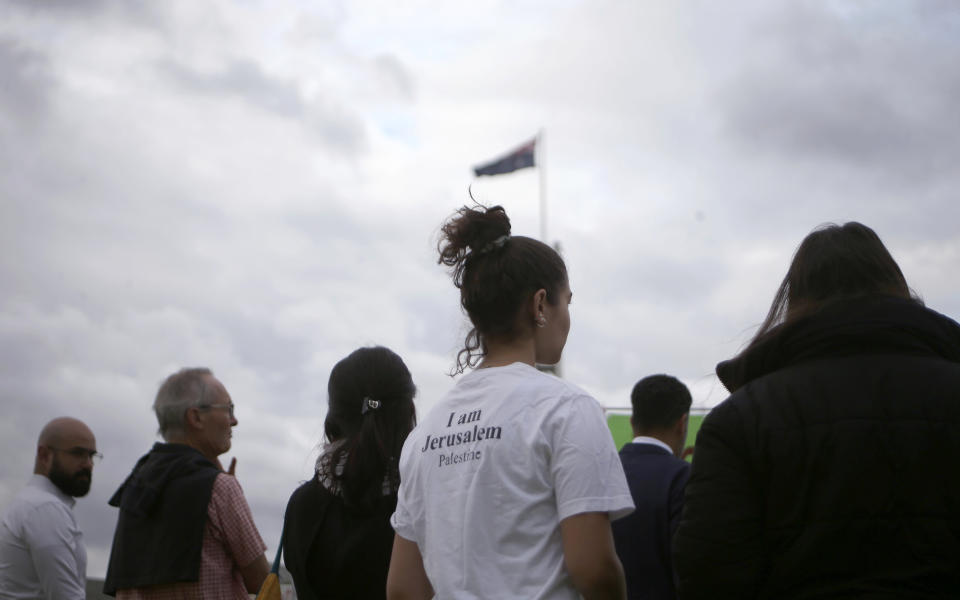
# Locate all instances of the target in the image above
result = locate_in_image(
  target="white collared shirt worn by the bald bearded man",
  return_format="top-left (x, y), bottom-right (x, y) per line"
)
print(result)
top-left (0, 475), bottom-right (87, 600)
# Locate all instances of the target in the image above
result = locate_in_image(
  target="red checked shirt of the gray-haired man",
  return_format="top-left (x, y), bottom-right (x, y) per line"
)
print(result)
top-left (117, 473), bottom-right (267, 600)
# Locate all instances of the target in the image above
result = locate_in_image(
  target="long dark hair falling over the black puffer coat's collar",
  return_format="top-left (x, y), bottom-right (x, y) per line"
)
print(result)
top-left (747, 221), bottom-right (920, 349)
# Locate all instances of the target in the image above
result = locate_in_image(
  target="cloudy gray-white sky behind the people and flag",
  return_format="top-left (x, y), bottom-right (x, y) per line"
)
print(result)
top-left (0, 0), bottom-right (960, 576)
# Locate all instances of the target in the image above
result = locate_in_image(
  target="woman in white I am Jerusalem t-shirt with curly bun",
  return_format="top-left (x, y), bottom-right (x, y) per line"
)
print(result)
top-left (387, 205), bottom-right (633, 599)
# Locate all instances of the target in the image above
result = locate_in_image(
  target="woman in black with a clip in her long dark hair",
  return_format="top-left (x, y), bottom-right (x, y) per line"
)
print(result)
top-left (283, 346), bottom-right (416, 600)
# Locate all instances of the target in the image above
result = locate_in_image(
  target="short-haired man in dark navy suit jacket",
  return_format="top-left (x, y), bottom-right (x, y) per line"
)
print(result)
top-left (613, 375), bottom-right (692, 600)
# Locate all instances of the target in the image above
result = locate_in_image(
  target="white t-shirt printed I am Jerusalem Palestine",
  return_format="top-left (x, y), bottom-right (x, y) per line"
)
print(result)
top-left (391, 363), bottom-right (633, 600)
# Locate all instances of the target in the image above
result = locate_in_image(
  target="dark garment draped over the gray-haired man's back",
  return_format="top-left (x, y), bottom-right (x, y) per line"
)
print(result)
top-left (103, 443), bottom-right (221, 596)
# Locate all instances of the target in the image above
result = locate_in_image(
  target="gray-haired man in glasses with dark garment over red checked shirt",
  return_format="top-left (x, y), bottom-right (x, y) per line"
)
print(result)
top-left (104, 368), bottom-right (269, 600)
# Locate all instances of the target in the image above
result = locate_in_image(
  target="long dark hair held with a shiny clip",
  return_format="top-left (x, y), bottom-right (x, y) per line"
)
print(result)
top-left (317, 346), bottom-right (417, 511)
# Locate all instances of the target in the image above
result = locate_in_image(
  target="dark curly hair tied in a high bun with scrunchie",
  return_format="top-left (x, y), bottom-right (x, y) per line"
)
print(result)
top-left (437, 204), bottom-right (567, 373)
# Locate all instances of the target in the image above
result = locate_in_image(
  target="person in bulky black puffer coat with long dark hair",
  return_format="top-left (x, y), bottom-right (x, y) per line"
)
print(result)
top-left (674, 223), bottom-right (960, 600)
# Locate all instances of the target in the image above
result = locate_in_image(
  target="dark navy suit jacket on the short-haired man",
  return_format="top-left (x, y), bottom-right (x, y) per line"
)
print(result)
top-left (613, 443), bottom-right (690, 600)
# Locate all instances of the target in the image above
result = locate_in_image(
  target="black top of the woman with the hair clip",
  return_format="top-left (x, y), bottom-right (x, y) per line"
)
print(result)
top-left (283, 476), bottom-right (397, 600)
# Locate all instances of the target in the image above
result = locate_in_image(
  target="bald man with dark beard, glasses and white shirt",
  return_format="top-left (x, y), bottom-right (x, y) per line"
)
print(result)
top-left (0, 417), bottom-right (100, 600)
